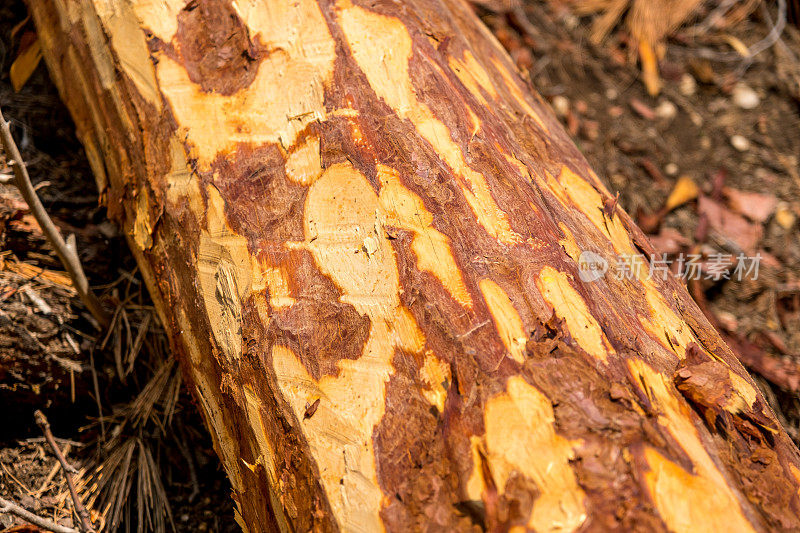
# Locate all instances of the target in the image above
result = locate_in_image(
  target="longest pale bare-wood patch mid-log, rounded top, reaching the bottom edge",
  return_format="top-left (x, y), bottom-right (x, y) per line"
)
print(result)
top-left (272, 164), bottom-right (425, 530)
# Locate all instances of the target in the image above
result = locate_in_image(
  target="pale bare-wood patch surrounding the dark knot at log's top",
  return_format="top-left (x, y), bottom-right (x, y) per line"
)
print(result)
top-left (149, 0), bottom-right (335, 169)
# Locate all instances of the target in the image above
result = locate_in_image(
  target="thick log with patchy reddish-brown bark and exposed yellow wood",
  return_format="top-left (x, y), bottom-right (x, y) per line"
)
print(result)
top-left (29, 0), bottom-right (800, 532)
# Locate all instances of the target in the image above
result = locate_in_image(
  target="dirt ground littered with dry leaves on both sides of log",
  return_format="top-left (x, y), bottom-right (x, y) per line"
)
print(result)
top-left (0, 1), bottom-right (800, 531)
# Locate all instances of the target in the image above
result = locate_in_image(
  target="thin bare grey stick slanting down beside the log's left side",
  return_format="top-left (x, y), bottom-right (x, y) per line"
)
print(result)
top-left (0, 109), bottom-right (109, 326)
